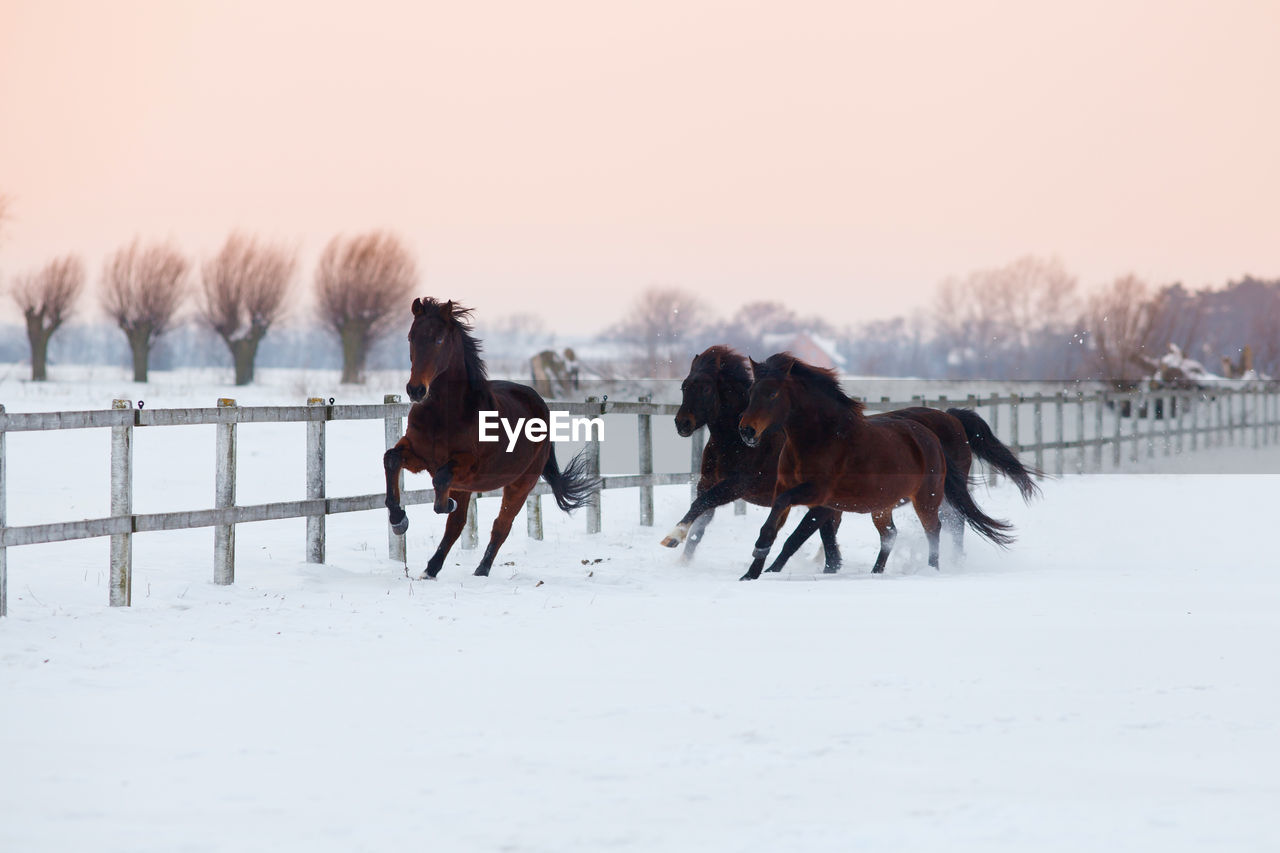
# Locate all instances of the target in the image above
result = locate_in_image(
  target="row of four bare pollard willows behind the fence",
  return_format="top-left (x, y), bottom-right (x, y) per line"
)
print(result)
top-left (0, 229), bottom-right (419, 386)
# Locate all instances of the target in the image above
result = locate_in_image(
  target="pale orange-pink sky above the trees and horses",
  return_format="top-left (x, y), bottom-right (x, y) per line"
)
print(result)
top-left (0, 0), bottom-right (1280, 333)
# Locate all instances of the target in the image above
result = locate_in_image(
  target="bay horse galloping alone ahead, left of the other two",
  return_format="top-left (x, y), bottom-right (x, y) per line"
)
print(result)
top-left (383, 297), bottom-right (599, 579)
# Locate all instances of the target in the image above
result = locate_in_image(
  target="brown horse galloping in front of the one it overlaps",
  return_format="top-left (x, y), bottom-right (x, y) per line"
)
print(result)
top-left (739, 352), bottom-right (1012, 580)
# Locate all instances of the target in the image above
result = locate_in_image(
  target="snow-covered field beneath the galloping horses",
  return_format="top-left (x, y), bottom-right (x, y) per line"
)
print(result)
top-left (0, 371), bottom-right (1280, 852)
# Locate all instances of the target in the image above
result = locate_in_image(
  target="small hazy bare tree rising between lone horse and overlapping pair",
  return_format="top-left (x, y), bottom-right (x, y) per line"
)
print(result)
top-left (609, 287), bottom-right (707, 378)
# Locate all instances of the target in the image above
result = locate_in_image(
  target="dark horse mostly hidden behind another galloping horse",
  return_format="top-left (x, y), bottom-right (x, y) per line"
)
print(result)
top-left (662, 346), bottom-right (1037, 573)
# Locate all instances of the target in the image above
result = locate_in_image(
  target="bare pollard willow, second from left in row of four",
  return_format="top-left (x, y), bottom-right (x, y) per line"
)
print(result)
top-left (101, 240), bottom-right (191, 382)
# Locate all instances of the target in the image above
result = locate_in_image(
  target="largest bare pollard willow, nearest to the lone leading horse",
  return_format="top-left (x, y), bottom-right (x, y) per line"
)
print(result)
top-left (316, 231), bottom-right (417, 383)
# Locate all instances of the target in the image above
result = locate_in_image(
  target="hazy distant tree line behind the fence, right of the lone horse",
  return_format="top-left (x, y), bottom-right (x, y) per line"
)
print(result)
top-left (600, 256), bottom-right (1280, 384)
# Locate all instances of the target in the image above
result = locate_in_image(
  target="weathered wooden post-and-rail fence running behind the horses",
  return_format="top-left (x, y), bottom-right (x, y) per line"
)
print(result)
top-left (0, 384), bottom-right (1280, 616)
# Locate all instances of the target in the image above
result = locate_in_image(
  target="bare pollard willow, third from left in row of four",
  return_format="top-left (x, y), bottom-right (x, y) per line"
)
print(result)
top-left (200, 234), bottom-right (297, 386)
